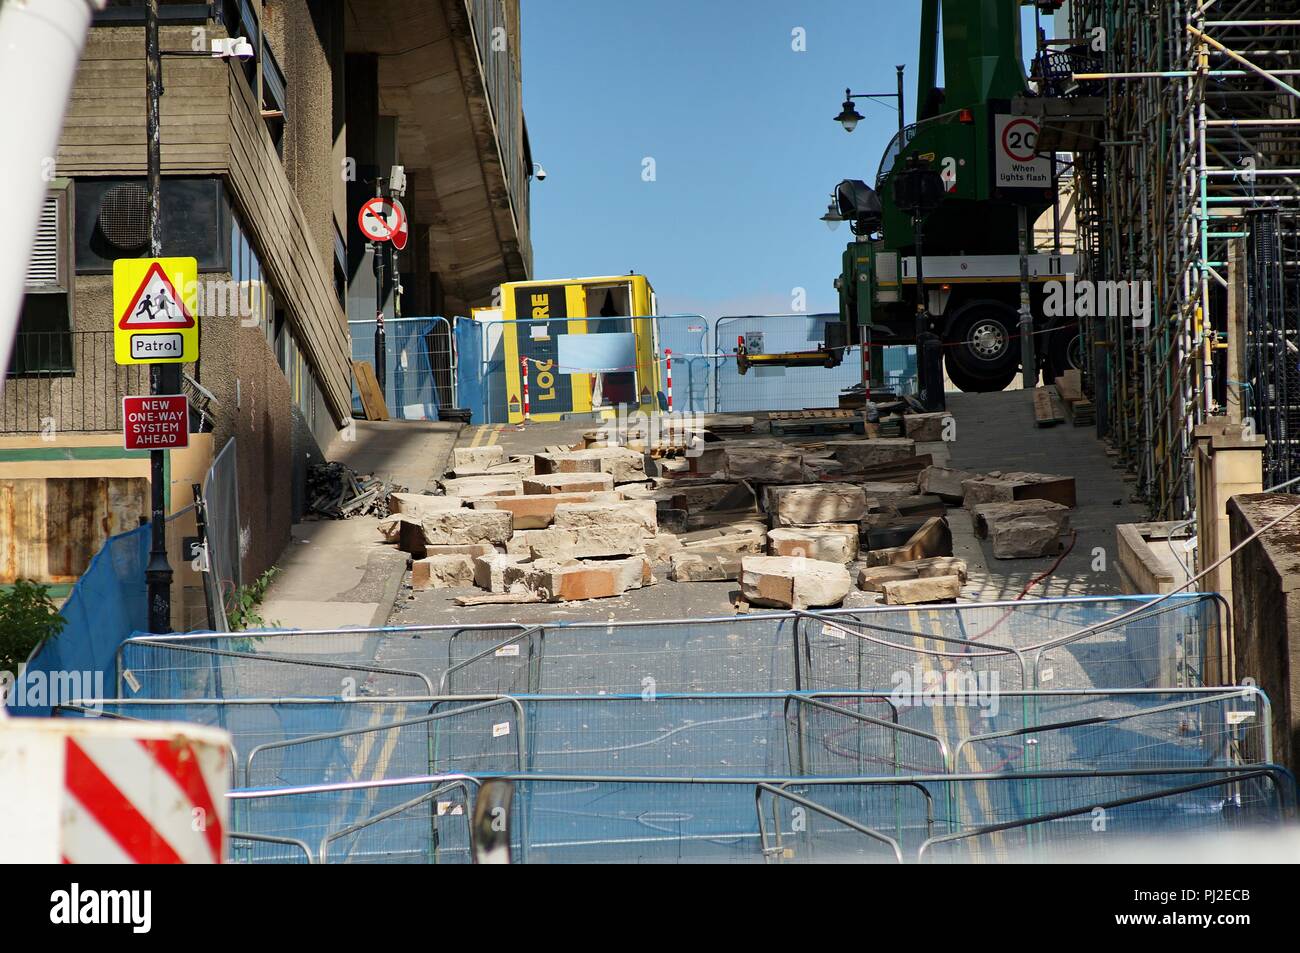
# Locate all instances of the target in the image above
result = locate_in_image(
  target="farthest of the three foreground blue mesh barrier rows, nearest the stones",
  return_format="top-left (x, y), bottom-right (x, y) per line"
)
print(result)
top-left (112, 593), bottom-right (1225, 698)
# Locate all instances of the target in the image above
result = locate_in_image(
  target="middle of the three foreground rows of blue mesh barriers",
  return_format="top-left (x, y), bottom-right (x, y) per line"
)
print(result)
top-left (57, 684), bottom-right (1273, 790)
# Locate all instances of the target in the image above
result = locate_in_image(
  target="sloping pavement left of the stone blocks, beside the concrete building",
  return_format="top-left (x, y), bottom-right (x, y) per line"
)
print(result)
top-left (259, 420), bottom-right (462, 629)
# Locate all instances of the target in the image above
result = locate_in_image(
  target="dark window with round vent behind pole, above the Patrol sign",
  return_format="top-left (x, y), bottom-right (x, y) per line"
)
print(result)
top-left (74, 177), bottom-right (230, 274)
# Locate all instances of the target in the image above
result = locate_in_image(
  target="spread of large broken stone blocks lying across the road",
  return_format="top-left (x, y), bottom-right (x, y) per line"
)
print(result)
top-left (381, 413), bottom-right (1074, 610)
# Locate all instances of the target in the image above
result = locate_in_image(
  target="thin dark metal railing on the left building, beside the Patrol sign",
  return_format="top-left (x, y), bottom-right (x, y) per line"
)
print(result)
top-left (0, 330), bottom-right (150, 438)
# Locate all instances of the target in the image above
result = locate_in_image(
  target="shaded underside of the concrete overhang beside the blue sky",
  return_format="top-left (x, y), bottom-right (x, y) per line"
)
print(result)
top-left (346, 0), bottom-right (532, 307)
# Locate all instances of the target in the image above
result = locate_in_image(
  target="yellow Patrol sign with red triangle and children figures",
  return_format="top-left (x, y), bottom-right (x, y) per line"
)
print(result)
top-left (113, 259), bottom-right (199, 364)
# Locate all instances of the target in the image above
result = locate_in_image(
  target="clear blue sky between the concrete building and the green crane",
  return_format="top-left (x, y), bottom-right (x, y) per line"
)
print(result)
top-left (521, 0), bottom-right (1032, 316)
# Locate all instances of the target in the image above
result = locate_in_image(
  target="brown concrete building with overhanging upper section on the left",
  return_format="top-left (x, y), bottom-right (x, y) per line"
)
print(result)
top-left (0, 0), bottom-right (533, 625)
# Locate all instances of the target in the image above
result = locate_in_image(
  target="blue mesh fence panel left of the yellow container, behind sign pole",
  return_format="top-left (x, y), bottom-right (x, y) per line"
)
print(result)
top-left (347, 317), bottom-right (456, 420)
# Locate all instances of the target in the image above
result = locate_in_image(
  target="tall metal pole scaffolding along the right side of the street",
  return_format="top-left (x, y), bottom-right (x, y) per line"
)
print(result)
top-left (1055, 0), bottom-right (1300, 520)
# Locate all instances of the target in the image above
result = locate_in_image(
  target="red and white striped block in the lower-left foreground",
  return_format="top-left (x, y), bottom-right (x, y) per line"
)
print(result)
top-left (0, 718), bottom-right (230, 863)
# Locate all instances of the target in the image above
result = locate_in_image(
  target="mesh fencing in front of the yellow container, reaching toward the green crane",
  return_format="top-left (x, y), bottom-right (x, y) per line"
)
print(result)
top-left (455, 315), bottom-right (915, 423)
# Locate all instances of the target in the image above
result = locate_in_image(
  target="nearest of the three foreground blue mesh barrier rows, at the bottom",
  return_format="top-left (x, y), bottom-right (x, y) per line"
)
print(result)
top-left (210, 764), bottom-right (1295, 863)
